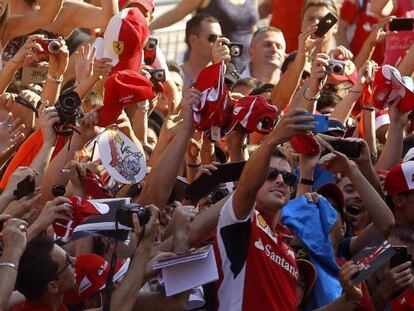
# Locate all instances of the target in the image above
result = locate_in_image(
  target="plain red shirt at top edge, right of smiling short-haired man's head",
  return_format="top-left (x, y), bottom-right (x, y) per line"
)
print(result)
top-left (270, 0), bottom-right (305, 53)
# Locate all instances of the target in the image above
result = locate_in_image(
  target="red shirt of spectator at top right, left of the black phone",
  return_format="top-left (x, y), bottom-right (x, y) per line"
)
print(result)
top-left (340, 0), bottom-right (385, 64)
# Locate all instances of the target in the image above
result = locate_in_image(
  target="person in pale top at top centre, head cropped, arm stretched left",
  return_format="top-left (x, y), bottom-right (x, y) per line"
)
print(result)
top-left (151, 0), bottom-right (259, 72)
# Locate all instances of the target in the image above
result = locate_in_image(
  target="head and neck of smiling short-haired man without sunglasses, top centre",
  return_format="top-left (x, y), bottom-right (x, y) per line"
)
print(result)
top-left (240, 27), bottom-right (286, 84)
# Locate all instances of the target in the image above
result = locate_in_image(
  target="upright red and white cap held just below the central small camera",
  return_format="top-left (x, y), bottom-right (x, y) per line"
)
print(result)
top-left (192, 62), bottom-right (231, 131)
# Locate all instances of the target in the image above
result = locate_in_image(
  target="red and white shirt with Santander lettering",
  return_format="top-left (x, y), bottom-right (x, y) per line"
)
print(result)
top-left (216, 196), bottom-right (298, 311)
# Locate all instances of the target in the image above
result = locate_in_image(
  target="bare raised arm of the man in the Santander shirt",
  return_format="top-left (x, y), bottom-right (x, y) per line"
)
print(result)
top-left (233, 109), bottom-right (313, 220)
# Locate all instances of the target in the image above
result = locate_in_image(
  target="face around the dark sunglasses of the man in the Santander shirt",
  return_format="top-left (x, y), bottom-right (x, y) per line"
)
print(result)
top-left (256, 157), bottom-right (292, 215)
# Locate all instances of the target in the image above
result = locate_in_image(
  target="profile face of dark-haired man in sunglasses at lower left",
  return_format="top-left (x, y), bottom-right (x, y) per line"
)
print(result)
top-left (52, 245), bottom-right (76, 293)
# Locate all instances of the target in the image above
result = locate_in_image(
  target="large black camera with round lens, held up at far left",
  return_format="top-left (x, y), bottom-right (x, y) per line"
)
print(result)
top-left (55, 92), bottom-right (84, 136)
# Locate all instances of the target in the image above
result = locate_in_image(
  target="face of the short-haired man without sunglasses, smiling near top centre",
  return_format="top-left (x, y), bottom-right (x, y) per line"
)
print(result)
top-left (249, 31), bottom-right (286, 68)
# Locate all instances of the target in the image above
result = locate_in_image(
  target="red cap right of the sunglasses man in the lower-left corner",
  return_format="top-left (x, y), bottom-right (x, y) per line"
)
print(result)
top-left (75, 254), bottom-right (130, 300)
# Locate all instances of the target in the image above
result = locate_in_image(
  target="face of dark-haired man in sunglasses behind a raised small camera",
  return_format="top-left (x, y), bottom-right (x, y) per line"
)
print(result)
top-left (189, 21), bottom-right (222, 60)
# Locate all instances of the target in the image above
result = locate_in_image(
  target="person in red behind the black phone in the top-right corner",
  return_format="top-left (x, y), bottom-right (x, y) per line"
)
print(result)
top-left (371, 0), bottom-right (414, 66)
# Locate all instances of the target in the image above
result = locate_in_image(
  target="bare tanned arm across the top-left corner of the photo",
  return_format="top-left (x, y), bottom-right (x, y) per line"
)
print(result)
top-left (1, 0), bottom-right (63, 46)
